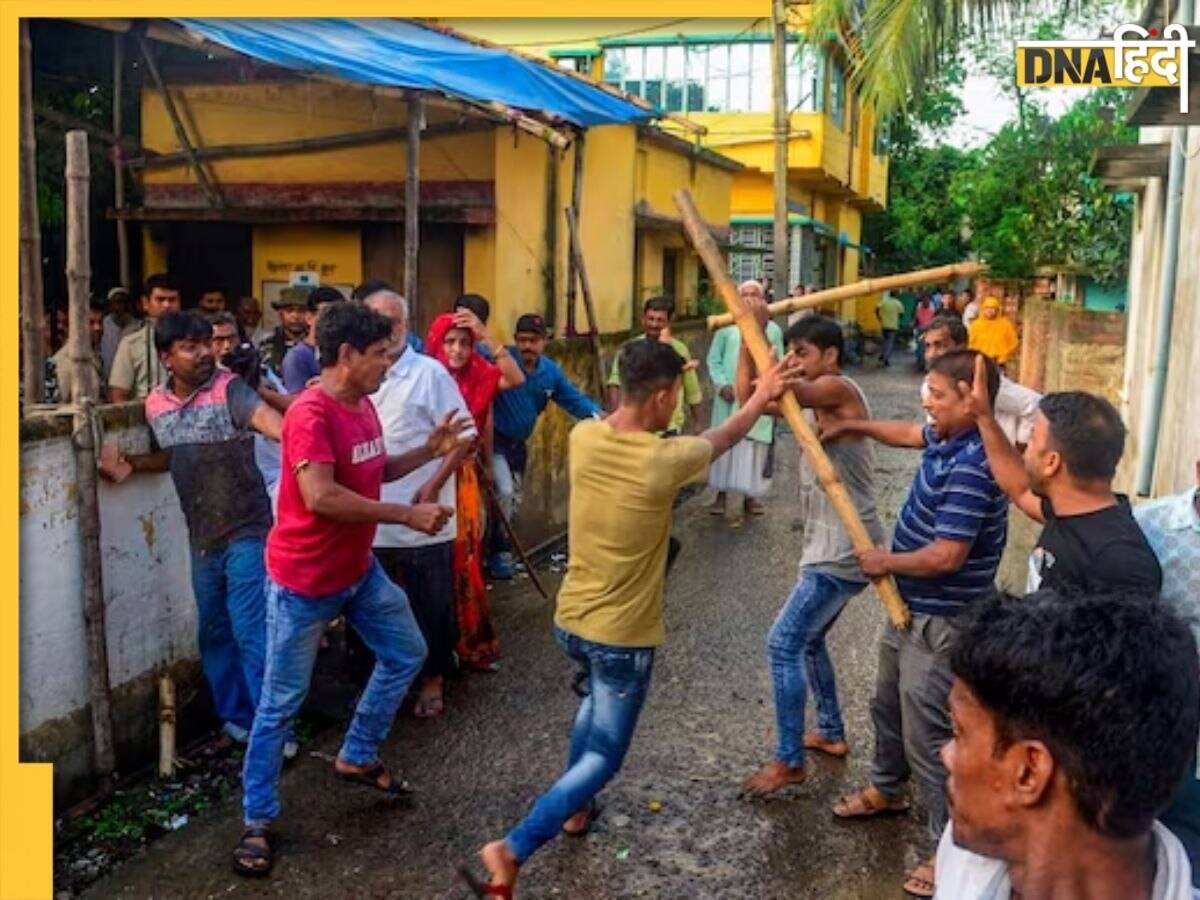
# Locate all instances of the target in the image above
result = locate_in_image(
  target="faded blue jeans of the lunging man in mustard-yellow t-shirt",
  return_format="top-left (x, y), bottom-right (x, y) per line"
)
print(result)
top-left (505, 628), bottom-right (654, 863)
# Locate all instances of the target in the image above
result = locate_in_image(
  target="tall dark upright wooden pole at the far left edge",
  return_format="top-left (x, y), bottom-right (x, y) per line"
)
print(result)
top-left (18, 19), bottom-right (46, 407)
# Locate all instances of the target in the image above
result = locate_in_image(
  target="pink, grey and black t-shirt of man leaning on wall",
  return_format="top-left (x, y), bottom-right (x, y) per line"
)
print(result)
top-left (146, 372), bottom-right (271, 552)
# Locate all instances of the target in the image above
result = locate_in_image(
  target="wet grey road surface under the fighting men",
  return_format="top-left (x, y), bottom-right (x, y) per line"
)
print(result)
top-left (79, 365), bottom-right (979, 900)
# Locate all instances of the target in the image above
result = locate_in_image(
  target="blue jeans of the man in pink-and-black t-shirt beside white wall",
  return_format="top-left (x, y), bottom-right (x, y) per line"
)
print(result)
top-left (192, 538), bottom-right (266, 731)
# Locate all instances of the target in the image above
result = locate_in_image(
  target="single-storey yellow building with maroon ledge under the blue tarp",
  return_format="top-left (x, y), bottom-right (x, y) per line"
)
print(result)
top-left (128, 63), bottom-right (742, 335)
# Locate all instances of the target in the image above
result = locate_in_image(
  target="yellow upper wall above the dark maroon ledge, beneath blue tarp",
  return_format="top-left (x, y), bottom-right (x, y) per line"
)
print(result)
top-left (142, 82), bottom-right (494, 184)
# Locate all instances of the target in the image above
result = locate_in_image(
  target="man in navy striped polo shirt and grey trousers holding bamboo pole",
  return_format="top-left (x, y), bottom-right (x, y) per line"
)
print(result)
top-left (833, 350), bottom-right (1008, 896)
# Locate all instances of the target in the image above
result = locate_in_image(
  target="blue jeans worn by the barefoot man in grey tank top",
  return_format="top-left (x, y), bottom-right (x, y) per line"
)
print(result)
top-left (767, 569), bottom-right (866, 767)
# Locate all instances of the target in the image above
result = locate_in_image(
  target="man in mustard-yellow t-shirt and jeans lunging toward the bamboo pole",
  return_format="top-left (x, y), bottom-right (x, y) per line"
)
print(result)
top-left (460, 341), bottom-right (799, 896)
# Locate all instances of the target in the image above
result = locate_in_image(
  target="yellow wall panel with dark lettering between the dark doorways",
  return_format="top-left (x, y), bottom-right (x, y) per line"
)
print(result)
top-left (251, 223), bottom-right (362, 325)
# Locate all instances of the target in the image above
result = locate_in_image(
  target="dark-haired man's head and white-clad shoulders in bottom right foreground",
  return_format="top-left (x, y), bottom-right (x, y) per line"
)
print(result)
top-left (936, 590), bottom-right (1200, 900)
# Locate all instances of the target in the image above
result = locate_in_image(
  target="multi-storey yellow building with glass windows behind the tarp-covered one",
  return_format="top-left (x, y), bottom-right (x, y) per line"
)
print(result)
top-left (454, 15), bottom-right (888, 329)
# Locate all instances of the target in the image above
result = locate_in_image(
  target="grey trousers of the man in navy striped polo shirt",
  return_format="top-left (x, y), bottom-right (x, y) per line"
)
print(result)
top-left (870, 613), bottom-right (955, 853)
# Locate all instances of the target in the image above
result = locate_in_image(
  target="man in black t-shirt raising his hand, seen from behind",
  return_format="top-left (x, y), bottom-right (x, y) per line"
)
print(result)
top-left (959, 355), bottom-right (1163, 595)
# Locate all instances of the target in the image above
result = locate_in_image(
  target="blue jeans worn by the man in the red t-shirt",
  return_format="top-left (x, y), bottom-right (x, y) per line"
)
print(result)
top-left (242, 558), bottom-right (425, 826)
